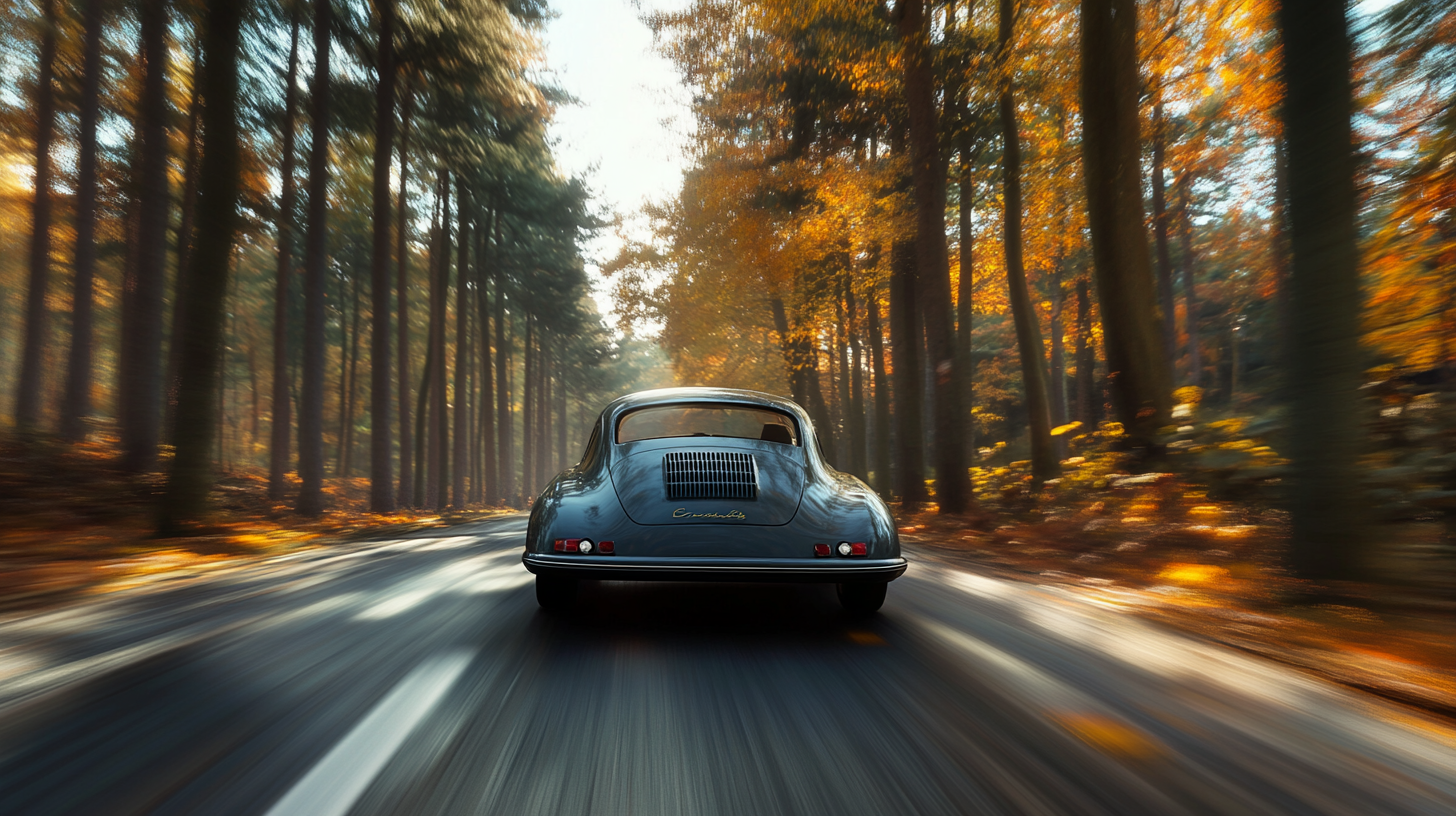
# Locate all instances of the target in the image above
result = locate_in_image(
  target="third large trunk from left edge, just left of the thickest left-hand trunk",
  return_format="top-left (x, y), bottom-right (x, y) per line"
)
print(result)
top-left (116, 0), bottom-right (172, 474)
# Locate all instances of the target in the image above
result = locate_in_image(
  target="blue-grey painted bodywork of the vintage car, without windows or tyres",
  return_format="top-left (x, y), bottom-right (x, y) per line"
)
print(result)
top-left (523, 388), bottom-right (906, 583)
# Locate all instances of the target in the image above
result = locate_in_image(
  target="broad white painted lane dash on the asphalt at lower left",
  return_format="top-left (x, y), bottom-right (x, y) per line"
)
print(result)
top-left (268, 650), bottom-right (475, 816)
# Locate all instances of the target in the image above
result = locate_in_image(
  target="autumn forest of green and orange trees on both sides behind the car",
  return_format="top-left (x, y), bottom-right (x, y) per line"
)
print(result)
top-left (0, 0), bottom-right (1456, 577)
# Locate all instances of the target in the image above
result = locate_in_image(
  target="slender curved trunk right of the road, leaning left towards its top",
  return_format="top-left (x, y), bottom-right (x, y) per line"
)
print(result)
top-left (995, 0), bottom-right (1059, 485)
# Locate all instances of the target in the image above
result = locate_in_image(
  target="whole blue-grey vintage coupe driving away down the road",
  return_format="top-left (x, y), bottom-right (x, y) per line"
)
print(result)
top-left (523, 388), bottom-right (906, 615)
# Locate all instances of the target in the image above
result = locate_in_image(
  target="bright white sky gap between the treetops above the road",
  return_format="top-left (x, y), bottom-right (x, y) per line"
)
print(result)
top-left (546, 0), bottom-right (692, 324)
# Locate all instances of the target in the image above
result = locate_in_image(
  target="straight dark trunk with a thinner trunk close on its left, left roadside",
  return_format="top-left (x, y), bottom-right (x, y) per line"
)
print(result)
top-left (296, 0), bottom-right (333, 516)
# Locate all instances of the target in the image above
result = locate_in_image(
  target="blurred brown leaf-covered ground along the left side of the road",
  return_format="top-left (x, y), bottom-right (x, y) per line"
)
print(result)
top-left (0, 440), bottom-right (502, 612)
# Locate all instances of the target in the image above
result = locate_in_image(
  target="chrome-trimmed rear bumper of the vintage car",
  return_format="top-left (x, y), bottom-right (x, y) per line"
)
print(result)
top-left (521, 552), bottom-right (907, 584)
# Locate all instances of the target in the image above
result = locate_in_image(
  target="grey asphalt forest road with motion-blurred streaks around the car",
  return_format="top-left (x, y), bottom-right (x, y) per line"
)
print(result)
top-left (0, 516), bottom-right (1456, 816)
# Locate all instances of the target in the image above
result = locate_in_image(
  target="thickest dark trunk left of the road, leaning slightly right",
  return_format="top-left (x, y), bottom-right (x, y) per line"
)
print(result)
top-left (157, 0), bottom-right (248, 535)
